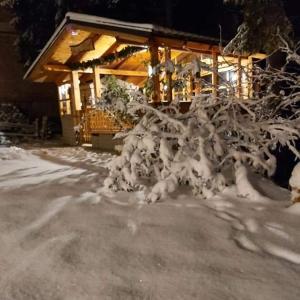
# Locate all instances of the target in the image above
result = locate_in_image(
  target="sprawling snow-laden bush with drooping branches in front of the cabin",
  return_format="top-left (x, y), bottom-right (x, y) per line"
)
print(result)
top-left (105, 47), bottom-right (300, 202)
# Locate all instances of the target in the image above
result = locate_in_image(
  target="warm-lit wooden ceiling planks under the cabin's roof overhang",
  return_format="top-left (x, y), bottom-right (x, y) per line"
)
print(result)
top-left (32, 19), bottom-right (244, 86)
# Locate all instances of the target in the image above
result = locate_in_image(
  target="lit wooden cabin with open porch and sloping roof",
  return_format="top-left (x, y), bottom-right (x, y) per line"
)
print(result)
top-left (24, 13), bottom-right (262, 149)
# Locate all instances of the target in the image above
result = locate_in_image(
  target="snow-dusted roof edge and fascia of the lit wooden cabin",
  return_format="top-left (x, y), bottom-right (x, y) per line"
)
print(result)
top-left (24, 12), bottom-right (219, 79)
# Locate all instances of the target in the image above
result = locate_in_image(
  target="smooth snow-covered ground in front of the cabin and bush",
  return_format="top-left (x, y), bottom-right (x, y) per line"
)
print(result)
top-left (0, 147), bottom-right (300, 300)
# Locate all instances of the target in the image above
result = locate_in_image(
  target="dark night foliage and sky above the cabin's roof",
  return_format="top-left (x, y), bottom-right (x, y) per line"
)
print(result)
top-left (0, 0), bottom-right (300, 65)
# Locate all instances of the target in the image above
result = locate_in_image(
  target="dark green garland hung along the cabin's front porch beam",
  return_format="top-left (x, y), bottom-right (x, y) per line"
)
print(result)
top-left (67, 46), bottom-right (145, 70)
